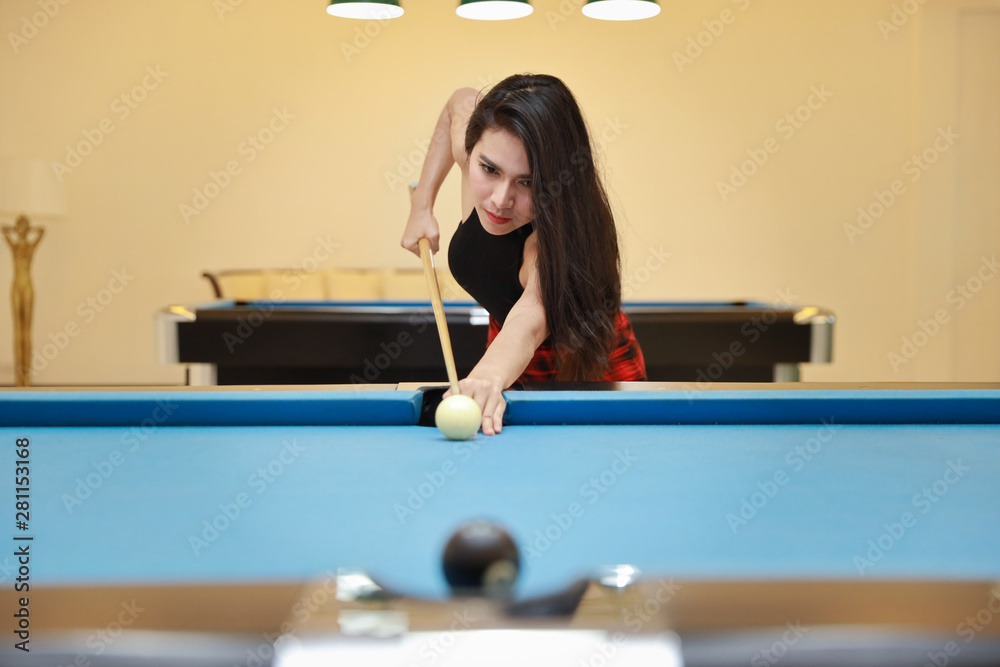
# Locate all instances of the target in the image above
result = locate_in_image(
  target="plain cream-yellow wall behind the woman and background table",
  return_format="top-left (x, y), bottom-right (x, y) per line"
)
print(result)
top-left (0, 0), bottom-right (1000, 384)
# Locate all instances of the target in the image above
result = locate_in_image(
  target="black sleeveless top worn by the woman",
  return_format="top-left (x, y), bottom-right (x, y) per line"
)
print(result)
top-left (448, 208), bottom-right (532, 327)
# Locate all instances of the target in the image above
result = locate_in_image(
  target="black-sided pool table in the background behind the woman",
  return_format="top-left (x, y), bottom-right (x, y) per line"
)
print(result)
top-left (158, 300), bottom-right (834, 385)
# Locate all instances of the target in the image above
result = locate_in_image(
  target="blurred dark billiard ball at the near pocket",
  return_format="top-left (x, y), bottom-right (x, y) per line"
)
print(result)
top-left (442, 520), bottom-right (521, 598)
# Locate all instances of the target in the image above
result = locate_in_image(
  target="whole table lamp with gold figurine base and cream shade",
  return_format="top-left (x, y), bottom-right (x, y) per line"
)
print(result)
top-left (0, 160), bottom-right (65, 387)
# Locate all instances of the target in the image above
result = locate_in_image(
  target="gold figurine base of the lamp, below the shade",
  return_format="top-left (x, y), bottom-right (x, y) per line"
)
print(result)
top-left (3, 215), bottom-right (45, 387)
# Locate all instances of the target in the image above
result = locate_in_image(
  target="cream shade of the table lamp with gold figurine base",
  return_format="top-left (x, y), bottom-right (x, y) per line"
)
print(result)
top-left (0, 159), bottom-right (66, 219)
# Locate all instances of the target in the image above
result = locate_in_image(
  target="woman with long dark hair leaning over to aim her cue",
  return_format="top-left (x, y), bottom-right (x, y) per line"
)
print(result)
top-left (401, 75), bottom-right (646, 435)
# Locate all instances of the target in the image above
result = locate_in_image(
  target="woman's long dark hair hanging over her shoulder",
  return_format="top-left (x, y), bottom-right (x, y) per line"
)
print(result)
top-left (465, 74), bottom-right (621, 380)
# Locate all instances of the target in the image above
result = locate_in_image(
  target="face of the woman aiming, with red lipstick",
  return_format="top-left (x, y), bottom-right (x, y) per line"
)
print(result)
top-left (469, 129), bottom-right (535, 235)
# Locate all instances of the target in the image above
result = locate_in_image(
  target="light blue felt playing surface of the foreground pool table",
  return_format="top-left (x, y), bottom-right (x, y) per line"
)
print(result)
top-left (0, 418), bottom-right (1000, 595)
